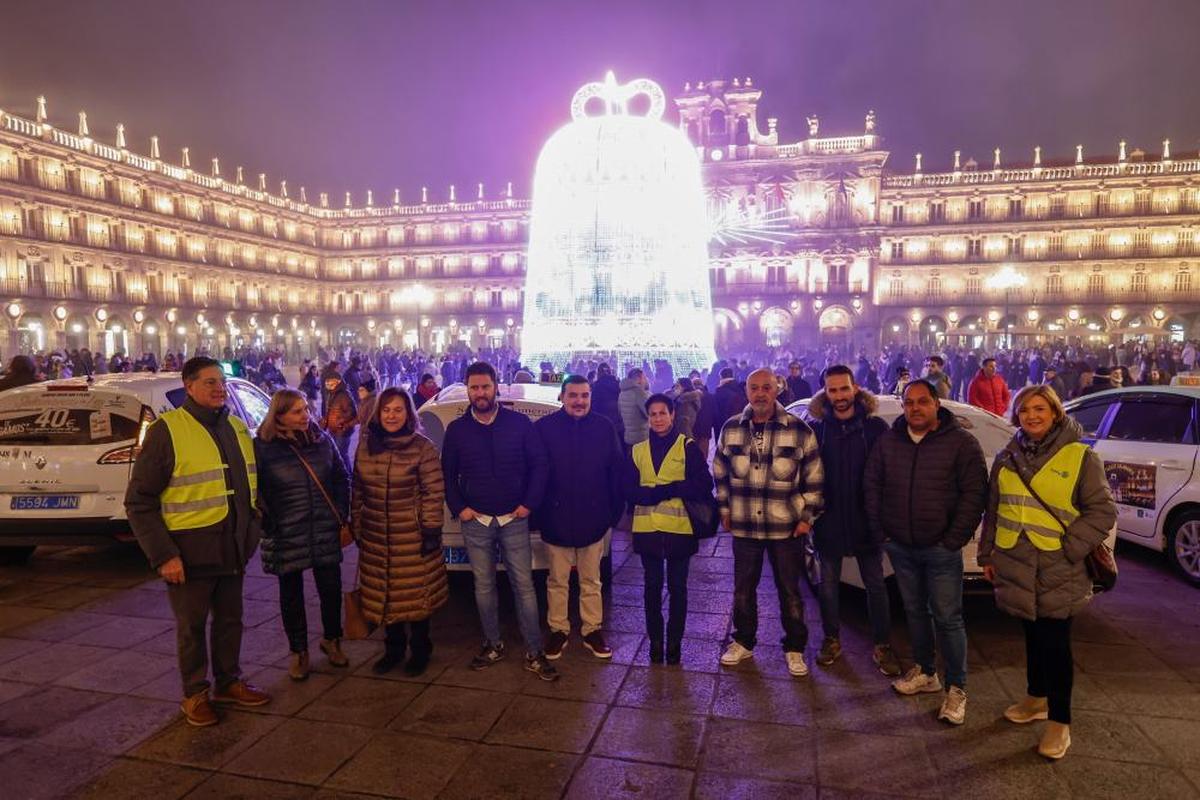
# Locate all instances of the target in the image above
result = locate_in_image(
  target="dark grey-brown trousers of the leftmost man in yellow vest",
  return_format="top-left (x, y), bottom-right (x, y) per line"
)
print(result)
top-left (167, 575), bottom-right (242, 697)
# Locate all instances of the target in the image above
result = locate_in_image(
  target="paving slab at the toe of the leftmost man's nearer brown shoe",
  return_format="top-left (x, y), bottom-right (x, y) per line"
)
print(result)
top-left (130, 711), bottom-right (284, 770)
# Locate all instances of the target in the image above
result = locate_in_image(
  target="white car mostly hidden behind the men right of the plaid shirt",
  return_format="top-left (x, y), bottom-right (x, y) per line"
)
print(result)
top-left (787, 395), bottom-right (1015, 593)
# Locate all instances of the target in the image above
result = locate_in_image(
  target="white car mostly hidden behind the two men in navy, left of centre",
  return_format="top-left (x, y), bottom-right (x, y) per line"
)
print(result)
top-left (416, 384), bottom-right (562, 571)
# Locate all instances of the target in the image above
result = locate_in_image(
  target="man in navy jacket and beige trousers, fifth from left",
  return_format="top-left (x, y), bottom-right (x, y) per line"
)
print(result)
top-left (533, 375), bottom-right (625, 660)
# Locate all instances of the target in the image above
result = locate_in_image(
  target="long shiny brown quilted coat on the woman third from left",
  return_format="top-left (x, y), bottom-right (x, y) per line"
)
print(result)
top-left (350, 428), bottom-right (449, 625)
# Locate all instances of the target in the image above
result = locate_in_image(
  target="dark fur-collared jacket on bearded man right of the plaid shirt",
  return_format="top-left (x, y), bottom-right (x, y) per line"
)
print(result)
top-left (808, 389), bottom-right (888, 559)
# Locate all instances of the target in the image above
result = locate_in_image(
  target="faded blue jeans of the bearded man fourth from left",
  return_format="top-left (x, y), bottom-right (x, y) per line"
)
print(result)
top-left (462, 519), bottom-right (542, 655)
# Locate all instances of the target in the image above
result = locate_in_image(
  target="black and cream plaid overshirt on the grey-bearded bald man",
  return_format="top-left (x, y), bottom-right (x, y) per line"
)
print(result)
top-left (713, 403), bottom-right (824, 539)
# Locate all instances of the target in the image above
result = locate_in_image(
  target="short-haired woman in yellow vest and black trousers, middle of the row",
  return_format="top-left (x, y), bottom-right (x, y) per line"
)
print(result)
top-left (624, 395), bottom-right (713, 664)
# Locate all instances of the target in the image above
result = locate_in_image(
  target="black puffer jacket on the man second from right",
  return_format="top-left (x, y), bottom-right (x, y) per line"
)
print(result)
top-left (863, 407), bottom-right (988, 551)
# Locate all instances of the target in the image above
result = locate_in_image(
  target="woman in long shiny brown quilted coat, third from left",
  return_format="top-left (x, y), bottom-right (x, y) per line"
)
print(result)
top-left (350, 387), bottom-right (449, 676)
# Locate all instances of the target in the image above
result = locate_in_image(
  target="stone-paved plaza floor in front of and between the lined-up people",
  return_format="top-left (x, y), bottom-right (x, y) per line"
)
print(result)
top-left (0, 534), bottom-right (1200, 800)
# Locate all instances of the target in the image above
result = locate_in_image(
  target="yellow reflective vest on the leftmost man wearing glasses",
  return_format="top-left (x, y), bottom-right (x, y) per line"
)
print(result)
top-left (158, 408), bottom-right (258, 533)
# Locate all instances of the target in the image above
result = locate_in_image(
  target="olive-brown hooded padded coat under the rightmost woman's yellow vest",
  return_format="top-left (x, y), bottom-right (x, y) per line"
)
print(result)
top-left (978, 416), bottom-right (1117, 620)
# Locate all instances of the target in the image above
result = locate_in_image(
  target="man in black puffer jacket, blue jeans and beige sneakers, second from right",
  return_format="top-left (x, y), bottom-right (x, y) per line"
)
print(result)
top-left (864, 378), bottom-right (988, 724)
